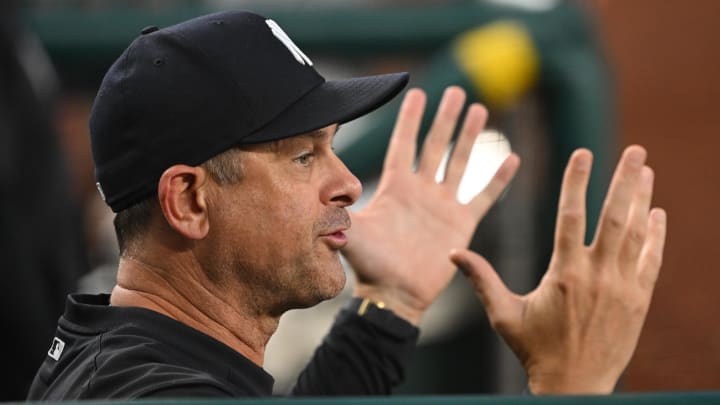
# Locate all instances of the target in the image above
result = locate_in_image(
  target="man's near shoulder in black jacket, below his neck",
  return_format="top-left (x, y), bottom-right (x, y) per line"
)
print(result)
top-left (31, 297), bottom-right (272, 400)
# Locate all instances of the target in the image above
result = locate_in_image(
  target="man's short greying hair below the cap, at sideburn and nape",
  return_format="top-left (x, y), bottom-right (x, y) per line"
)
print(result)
top-left (113, 147), bottom-right (243, 255)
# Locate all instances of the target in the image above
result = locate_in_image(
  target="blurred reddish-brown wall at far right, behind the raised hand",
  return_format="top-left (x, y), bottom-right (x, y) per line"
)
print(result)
top-left (591, 0), bottom-right (720, 390)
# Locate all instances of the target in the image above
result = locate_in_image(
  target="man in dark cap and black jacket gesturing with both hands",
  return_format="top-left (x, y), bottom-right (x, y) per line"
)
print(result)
top-left (29, 12), bottom-right (665, 400)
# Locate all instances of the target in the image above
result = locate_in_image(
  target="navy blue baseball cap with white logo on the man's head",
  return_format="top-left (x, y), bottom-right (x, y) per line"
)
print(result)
top-left (90, 11), bottom-right (408, 212)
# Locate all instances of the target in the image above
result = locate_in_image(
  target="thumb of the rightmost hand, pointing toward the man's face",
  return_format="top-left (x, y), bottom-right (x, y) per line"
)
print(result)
top-left (450, 249), bottom-right (519, 331)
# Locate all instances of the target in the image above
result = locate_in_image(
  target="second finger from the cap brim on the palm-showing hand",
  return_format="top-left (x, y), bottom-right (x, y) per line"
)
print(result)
top-left (417, 86), bottom-right (465, 178)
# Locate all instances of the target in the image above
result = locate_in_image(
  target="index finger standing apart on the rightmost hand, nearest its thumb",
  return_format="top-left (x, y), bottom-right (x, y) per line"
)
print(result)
top-left (554, 149), bottom-right (592, 259)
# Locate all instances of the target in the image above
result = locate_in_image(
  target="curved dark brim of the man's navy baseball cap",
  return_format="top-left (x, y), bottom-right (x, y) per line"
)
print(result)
top-left (240, 73), bottom-right (409, 144)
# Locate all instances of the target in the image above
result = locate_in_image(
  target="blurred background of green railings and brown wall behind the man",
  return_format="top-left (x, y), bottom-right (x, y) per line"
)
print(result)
top-left (0, 0), bottom-right (720, 400)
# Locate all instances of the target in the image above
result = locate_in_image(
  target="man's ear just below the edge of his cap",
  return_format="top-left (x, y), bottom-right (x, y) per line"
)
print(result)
top-left (158, 165), bottom-right (210, 240)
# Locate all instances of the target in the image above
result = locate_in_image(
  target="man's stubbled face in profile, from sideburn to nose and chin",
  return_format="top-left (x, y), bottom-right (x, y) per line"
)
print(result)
top-left (201, 125), bottom-right (362, 315)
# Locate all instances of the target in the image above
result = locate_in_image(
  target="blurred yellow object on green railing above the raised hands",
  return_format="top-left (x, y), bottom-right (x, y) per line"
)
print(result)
top-left (454, 21), bottom-right (539, 109)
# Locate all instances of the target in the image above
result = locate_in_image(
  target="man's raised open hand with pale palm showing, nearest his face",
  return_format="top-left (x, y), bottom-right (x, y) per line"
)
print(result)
top-left (343, 87), bottom-right (519, 324)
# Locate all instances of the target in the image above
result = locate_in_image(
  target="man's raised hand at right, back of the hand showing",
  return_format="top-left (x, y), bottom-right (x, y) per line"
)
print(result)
top-left (451, 146), bottom-right (666, 393)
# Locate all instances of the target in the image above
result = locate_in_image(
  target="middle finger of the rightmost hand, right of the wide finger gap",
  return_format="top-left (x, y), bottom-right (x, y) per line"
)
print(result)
top-left (593, 145), bottom-right (647, 261)
